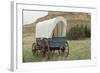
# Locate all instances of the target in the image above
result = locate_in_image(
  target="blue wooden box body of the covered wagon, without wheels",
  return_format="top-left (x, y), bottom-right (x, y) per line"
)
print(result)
top-left (36, 37), bottom-right (67, 48)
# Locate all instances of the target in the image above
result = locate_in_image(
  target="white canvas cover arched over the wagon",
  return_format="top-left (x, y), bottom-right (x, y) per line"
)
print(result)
top-left (36, 16), bottom-right (67, 38)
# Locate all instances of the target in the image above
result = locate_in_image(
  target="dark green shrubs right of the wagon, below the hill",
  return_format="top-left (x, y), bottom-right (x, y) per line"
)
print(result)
top-left (67, 25), bottom-right (91, 40)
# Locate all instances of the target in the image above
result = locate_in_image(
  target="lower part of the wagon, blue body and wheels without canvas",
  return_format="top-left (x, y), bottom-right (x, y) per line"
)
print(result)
top-left (32, 37), bottom-right (69, 58)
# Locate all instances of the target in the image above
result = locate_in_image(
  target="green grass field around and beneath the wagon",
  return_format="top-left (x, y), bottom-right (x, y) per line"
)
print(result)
top-left (23, 34), bottom-right (91, 62)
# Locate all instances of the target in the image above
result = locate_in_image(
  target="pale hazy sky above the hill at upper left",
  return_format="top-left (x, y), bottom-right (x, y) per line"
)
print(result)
top-left (23, 11), bottom-right (48, 25)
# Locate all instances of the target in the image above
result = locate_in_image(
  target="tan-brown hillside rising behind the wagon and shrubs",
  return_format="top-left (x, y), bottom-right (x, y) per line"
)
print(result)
top-left (23, 11), bottom-right (91, 33)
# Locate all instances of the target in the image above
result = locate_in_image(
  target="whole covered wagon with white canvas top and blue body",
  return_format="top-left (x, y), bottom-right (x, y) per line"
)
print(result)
top-left (32, 16), bottom-right (69, 56)
